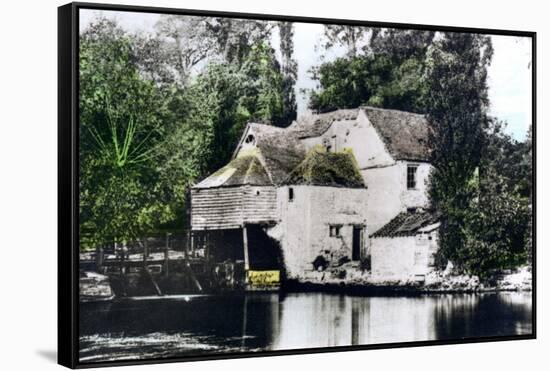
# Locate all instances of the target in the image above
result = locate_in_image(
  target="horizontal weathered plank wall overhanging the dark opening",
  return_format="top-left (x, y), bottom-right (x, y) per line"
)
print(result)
top-left (191, 185), bottom-right (277, 231)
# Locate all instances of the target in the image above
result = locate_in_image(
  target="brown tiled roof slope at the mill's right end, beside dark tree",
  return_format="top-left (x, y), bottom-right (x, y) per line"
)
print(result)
top-left (362, 107), bottom-right (430, 161)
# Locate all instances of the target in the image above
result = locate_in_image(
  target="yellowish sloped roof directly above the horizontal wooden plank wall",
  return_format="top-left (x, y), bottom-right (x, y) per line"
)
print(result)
top-left (193, 153), bottom-right (271, 188)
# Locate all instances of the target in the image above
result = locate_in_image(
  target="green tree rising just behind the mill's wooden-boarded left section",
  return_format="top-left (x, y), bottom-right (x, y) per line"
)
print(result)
top-left (190, 43), bottom-right (286, 174)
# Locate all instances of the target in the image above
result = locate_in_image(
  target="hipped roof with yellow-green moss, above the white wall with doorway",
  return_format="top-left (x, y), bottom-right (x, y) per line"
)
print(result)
top-left (285, 147), bottom-right (365, 188)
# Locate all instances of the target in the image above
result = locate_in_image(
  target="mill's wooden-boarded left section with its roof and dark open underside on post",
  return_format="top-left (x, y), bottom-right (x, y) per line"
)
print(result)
top-left (191, 124), bottom-right (305, 284)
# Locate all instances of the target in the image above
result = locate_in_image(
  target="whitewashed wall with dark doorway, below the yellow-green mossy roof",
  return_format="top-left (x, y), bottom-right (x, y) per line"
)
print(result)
top-left (276, 186), bottom-right (367, 277)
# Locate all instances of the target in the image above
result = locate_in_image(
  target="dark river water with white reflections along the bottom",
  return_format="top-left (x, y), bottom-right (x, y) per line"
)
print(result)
top-left (79, 292), bottom-right (532, 362)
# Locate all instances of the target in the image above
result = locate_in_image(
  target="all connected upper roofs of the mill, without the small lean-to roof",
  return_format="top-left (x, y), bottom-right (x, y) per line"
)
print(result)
top-left (195, 107), bottom-right (430, 188)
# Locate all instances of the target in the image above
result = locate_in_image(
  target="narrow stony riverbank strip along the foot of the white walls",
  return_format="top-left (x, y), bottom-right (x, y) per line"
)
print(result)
top-left (283, 265), bottom-right (532, 295)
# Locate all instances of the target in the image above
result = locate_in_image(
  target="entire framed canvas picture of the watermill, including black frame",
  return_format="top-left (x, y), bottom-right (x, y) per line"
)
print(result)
top-left (58, 3), bottom-right (536, 368)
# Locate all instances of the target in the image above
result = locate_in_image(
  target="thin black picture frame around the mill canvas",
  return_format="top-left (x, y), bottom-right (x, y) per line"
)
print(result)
top-left (58, 2), bottom-right (537, 368)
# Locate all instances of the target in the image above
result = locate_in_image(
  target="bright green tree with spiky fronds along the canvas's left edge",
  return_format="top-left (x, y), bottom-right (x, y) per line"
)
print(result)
top-left (79, 19), bottom-right (196, 247)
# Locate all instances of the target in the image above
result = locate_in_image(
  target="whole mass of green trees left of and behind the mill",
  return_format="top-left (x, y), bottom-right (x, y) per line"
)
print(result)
top-left (79, 16), bottom-right (295, 248)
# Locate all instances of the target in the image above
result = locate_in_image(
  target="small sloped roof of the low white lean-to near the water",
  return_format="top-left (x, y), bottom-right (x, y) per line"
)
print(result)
top-left (371, 211), bottom-right (441, 237)
